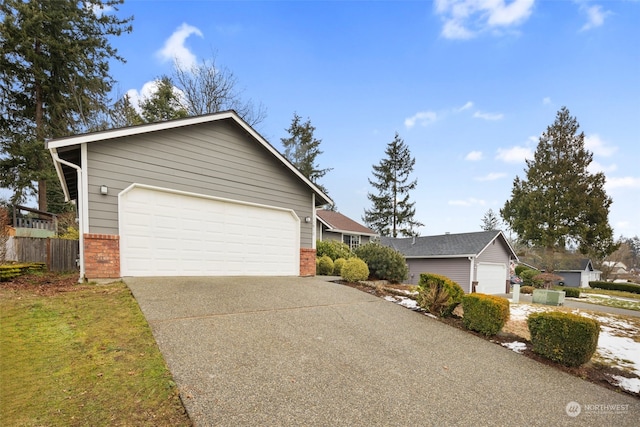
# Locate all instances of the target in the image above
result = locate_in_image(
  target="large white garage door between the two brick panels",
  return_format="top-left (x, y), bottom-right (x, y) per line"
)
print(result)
top-left (118, 185), bottom-right (300, 276)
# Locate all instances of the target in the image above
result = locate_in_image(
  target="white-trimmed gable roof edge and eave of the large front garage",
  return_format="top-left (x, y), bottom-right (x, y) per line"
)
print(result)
top-left (45, 111), bottom-right (333, 206)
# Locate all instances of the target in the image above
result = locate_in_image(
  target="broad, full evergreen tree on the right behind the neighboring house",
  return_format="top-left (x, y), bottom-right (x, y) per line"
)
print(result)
top-left (500, 107), bottom-right (616, 271)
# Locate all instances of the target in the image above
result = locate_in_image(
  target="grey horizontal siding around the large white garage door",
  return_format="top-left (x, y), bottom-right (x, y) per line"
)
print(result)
top-left (87, 121), bottom-right (313, 247)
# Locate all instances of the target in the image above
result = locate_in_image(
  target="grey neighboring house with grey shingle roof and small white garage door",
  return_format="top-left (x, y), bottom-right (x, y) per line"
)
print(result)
top-left (381, 230), bottom-right (518, 294)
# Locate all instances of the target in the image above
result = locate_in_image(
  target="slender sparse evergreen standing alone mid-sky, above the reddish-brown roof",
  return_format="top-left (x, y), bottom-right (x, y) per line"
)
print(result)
top-left (362, 132), bottom-right (424, 237)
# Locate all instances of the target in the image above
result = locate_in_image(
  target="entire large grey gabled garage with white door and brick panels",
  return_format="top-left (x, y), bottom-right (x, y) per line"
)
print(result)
top-left (46, 111), bottom-right (333, 278)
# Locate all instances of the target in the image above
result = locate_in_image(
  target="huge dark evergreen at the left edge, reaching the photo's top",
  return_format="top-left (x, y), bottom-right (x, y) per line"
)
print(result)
top-left (0, 0), bottom-right (132, 211)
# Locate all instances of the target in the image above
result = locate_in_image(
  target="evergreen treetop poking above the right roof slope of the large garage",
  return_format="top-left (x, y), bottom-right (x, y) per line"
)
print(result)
top-left (280, 113), bottom-right (331, 194)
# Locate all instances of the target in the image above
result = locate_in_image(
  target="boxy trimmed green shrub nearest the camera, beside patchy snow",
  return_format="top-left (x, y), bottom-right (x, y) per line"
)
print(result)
top-left (527, 311), bottom-right (600, 366)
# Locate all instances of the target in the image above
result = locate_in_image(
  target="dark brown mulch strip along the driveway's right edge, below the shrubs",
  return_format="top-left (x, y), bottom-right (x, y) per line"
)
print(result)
top-left (339, 281), bottom-right (640, 399)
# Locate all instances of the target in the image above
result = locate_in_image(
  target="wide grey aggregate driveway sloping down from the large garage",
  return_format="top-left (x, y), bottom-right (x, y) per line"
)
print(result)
top-left (125, 277), bottom-right (640, 426)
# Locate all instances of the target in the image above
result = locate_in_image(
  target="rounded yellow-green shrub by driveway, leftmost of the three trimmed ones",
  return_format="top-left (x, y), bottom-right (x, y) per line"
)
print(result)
top-left (416, 273), bottom-right (464, 316)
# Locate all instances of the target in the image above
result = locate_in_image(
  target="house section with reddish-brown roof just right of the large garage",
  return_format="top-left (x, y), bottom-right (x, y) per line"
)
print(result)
top-left (316, 209), bottom-right (378, 250)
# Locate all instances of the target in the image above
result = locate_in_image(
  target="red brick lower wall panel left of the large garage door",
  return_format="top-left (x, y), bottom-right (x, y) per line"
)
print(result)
top-left (84, 234), bottom-right (120, 279)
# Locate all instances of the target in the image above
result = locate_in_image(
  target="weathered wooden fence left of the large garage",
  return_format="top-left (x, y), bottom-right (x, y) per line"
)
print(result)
top-left (6, 237), bottom-right (79, 271)
